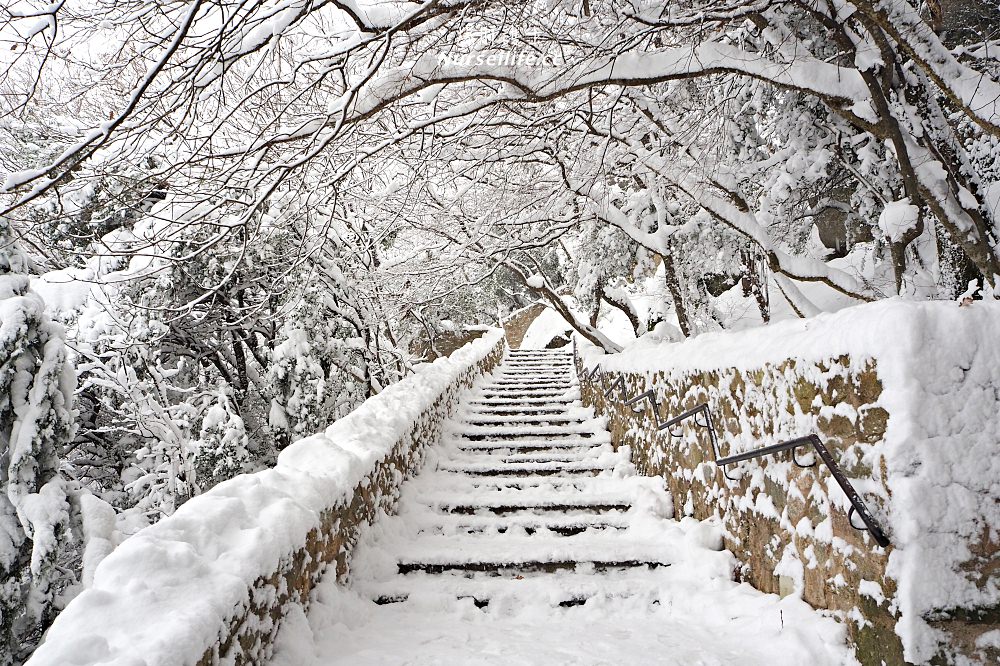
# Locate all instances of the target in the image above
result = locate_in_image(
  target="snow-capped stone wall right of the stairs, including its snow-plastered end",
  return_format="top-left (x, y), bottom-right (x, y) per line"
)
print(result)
top-left (581, 301), bottom-right (1000, 664)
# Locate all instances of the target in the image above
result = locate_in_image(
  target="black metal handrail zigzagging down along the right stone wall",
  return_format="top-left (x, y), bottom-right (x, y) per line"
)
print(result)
top-left (573, 339), bottom-right (890, 548)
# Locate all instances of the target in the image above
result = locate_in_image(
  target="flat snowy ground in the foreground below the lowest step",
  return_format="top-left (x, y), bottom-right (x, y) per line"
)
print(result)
top-left (272, 578), bottom-right (856, 666)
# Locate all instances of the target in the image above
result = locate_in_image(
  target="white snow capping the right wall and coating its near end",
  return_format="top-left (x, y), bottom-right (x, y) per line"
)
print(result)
top-left (580, 298), bottom-right (1000, 663)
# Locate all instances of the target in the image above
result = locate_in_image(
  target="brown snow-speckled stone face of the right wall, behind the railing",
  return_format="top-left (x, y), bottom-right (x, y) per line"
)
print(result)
top-left (581, 357), bottom-right (904, 665)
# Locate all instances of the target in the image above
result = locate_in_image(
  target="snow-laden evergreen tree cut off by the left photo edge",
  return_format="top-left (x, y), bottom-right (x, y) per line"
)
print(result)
top-left (0, 218), bottom-right (79, 664)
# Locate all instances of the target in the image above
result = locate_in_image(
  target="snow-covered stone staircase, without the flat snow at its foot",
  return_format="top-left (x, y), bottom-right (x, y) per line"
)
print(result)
top-left (355, 351), bottom-right (684, 607)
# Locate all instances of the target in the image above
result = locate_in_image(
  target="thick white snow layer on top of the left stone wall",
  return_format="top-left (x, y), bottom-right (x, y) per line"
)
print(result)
top-left (28, 329), bottom-right (503, 666)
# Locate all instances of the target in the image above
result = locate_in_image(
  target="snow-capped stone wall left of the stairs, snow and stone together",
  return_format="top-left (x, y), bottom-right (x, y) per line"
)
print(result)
top-left (28, 329), bottom-right (506, 666)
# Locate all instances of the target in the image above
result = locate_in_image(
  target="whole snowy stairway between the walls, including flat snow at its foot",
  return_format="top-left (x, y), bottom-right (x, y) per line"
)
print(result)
top-left (272, 351), bottom-right (856, 666)
